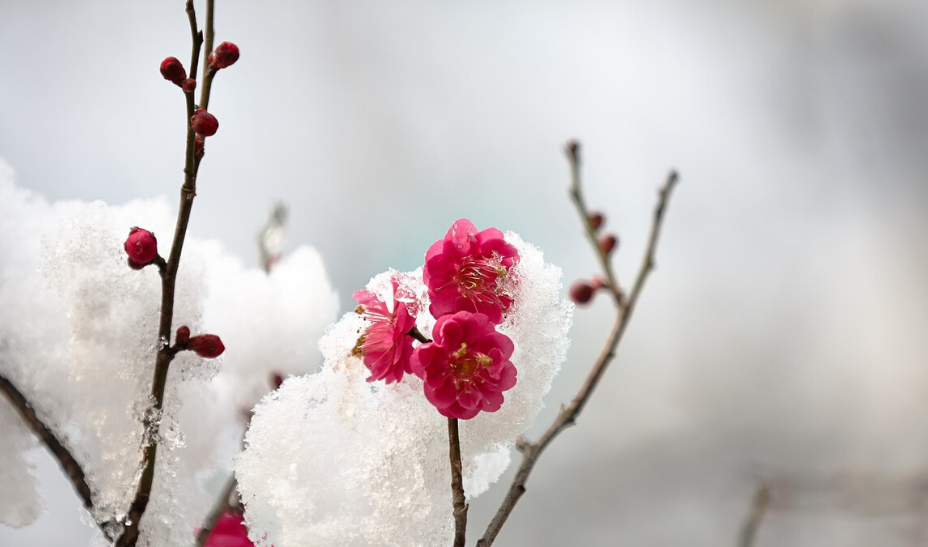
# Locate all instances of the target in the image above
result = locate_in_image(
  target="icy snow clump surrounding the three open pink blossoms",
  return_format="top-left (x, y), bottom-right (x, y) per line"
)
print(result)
top-left (235, 233), bottom-right (573, 547)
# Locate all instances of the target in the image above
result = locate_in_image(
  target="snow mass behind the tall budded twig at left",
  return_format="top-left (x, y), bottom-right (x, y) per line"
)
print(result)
top-left (0, 162), bottom-right (337, 546)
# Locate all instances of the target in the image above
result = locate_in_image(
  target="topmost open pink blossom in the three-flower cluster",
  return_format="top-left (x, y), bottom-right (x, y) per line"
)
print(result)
top-left (422, 218), bottom-right (519, 324)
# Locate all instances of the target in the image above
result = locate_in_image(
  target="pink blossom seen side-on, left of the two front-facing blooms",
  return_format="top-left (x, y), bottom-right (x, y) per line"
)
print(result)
top-left (352, 278), bottom-right (416, 384)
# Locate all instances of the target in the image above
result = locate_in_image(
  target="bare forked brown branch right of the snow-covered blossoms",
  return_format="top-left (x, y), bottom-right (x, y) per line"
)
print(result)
top-left (477, 145), bottom-right (678, 547)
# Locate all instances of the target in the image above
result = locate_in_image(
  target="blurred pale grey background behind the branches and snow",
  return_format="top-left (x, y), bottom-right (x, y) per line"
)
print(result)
top-left (0, 0), bottom-right (928, 547)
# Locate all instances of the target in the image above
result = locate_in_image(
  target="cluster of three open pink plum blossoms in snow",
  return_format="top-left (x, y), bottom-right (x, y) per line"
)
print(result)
top-left (354, 219), bottom-right (519, 420)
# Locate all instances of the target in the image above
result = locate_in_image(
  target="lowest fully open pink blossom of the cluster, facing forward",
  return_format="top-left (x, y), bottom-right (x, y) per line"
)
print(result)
top-left (412, 311), bottom-right (516, 420)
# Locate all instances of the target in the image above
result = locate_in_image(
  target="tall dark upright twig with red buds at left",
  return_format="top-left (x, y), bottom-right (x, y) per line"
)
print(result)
top-left (115, 1), bottom-right (213, 547)
